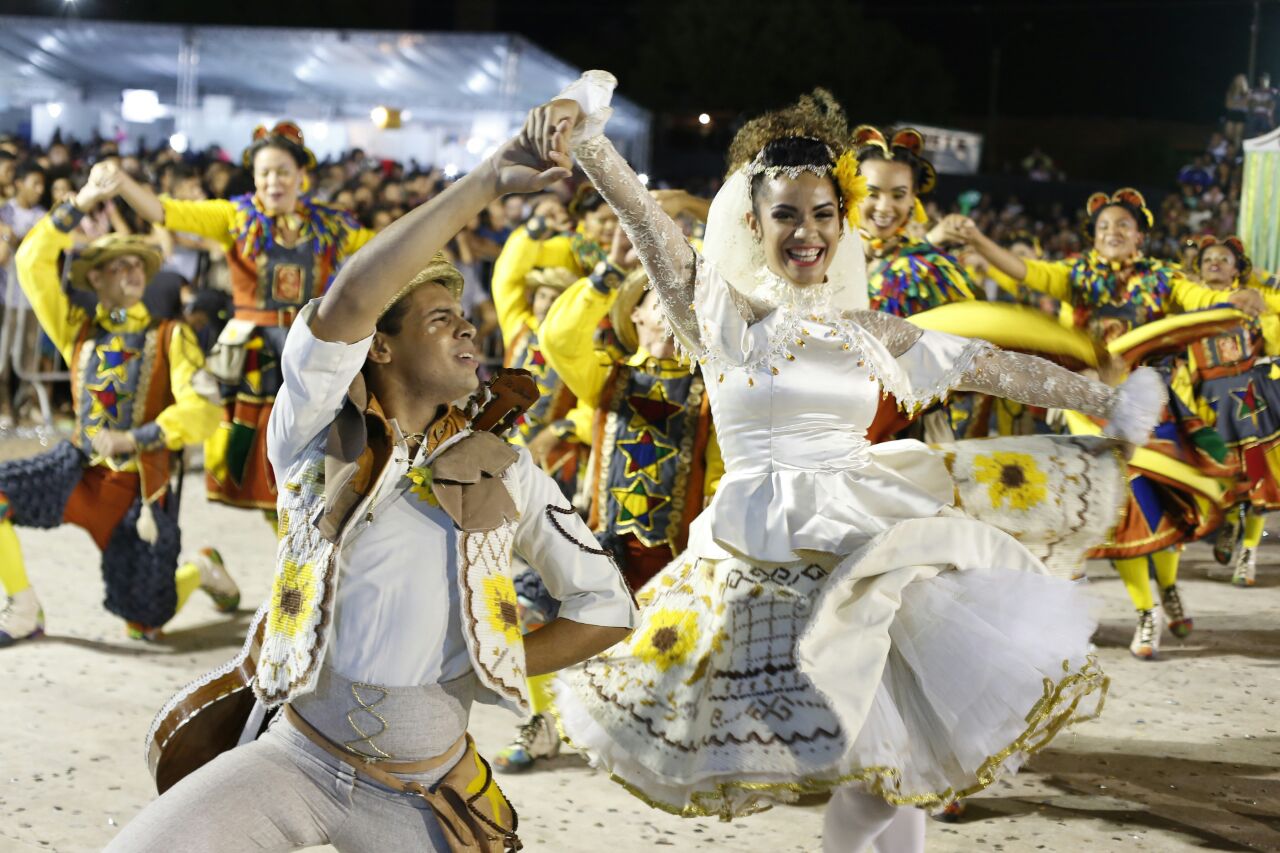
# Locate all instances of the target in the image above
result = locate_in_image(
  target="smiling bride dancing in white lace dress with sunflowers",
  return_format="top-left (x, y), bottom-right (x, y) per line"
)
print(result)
top-left (535, 72), bottom-right (1161, 850)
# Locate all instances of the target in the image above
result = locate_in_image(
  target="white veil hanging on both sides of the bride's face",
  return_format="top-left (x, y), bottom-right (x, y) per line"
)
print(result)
top-left (703, 165), bottom-right (868, 311)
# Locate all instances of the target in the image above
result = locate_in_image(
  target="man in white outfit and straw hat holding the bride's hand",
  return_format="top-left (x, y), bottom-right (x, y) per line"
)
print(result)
top-left (109, 106), bottom-right (635, 853)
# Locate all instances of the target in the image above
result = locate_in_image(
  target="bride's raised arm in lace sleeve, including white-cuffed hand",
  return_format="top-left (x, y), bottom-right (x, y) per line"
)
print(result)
top-left (535, 70), bottom-right (701, 351)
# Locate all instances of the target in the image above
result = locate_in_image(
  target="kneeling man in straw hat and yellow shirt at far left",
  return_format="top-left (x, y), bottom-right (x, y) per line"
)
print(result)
top-left (0, 172), bottom-right (239, 637)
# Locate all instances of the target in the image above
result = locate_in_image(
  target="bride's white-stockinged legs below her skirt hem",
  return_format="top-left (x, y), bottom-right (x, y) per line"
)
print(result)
top-left (822, 786), bottom-right (924, 853)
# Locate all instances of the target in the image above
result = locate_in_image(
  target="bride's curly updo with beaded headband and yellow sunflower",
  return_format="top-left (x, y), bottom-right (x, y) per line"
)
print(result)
top-left (728, 88), bottom-right (867, 228)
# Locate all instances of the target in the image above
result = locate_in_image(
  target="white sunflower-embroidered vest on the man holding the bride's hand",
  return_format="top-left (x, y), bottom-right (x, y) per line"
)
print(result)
top-left (253, 397), bottom-right (529, 713)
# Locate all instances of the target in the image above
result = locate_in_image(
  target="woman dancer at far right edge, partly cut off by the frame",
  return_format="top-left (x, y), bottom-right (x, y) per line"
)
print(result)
top-left (1172, 237), bottom-right (1280, 587)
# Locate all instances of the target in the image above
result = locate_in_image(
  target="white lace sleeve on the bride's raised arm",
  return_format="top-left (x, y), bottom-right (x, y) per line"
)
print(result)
top-left (573, 134), bottom-right (701, 352)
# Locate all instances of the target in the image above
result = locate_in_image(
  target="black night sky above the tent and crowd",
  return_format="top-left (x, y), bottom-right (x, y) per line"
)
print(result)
top-left (0, 0), bottom-right (1280, 177)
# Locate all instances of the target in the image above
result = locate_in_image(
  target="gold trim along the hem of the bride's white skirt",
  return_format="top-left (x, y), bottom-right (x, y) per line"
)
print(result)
top-left (593, 654), bottom-right (1111, 821)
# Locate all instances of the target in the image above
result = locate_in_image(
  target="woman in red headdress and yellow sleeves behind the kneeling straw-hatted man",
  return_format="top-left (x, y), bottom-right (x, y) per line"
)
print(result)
top-left (98, 122), bottom-right (374, 519)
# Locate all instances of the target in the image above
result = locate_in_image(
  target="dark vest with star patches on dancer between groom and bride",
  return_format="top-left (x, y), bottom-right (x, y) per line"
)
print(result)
top-left (589, 365), bottom-right (710, 553)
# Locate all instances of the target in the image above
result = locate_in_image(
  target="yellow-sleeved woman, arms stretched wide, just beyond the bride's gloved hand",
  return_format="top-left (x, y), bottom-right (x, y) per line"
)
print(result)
top-left (942, 194), bottom-right (1265, 661)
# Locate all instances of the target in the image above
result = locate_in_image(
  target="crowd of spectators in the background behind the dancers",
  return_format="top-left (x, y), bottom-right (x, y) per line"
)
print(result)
top-left (0, 69), bottom-right (1276, 429)
